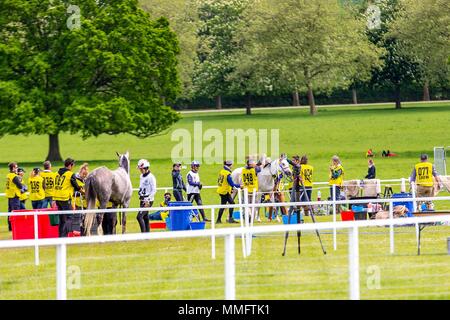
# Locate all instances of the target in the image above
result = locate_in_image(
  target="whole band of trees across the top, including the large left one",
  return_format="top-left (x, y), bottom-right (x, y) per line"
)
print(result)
top-left (0, 0), bottom-right (450, 161)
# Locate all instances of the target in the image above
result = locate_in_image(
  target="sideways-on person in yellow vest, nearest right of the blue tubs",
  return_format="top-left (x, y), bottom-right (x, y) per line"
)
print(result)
top-left (216, 160), bottom-right (241, 223)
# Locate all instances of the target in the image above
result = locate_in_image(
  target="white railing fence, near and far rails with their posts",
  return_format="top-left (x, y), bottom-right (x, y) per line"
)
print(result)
top-left (0, 197), bottom-right (450, 300)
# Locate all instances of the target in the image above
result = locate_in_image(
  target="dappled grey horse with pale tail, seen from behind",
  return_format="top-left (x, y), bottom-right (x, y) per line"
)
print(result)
top-left (84, 151), bottom-right (133, 236)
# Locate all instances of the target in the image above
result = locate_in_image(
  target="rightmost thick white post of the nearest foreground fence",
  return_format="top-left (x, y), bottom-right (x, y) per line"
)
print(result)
top-left (348, 226), bottom-right (360, 300)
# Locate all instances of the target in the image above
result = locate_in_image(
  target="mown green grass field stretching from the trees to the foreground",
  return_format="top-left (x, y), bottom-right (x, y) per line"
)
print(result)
top-left (0, 103), bottom-right (450, 299)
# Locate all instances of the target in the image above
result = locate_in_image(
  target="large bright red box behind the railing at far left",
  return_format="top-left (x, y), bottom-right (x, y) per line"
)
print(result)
top-left (9, 208), bottom-right (59, 240)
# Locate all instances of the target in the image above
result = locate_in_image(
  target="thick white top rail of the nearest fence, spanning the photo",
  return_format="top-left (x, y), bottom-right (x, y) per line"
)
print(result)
top-left (0, 214), bottom-right (450, 248)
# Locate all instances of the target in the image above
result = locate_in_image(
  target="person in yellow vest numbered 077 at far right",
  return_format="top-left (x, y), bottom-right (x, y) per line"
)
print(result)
top-left (409, 154), bottom-right (441, 209)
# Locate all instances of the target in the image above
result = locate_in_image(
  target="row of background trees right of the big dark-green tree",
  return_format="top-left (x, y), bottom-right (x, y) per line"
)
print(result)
top-left (142, 0), bottom-right (450, 115)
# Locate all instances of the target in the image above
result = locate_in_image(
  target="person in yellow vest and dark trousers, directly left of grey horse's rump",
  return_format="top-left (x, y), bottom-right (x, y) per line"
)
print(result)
top-left (53, 158), bottom-right (81, 237)
